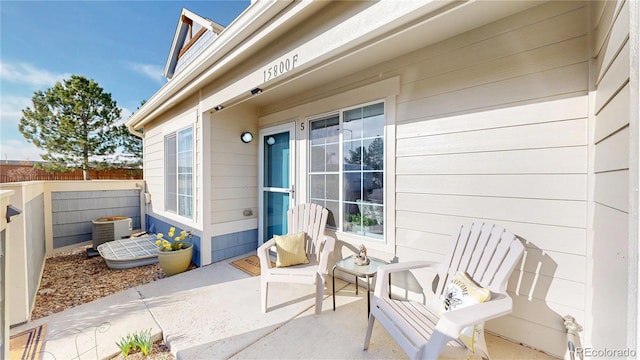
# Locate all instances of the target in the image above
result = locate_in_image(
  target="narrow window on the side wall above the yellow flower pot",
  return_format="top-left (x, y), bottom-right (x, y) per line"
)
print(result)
top-left (164, 128), bottom-right (193, 219)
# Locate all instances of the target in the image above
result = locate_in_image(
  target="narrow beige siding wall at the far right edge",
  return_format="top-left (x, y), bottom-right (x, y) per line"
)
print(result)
top-left (590, 1), bottom-right (637, 349)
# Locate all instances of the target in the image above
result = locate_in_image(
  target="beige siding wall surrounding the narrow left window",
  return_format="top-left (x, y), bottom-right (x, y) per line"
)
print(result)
top-left (144, 97), bottom-right (203, 229)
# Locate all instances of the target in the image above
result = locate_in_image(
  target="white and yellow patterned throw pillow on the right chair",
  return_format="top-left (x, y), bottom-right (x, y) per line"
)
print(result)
top-left (442, 271), bottom-right (491, 352)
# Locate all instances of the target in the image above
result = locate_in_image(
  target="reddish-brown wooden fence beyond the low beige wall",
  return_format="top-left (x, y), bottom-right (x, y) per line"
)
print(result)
top-left (0, 164), bottom-right (142, 183)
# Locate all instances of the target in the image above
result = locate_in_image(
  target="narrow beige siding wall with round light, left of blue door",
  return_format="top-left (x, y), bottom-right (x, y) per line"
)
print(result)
top-left (208, 107), bottom-right (259, 226)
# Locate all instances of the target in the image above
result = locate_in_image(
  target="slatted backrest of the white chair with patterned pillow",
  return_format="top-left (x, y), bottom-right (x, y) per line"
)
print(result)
top-left (437, 223), bottom-right (524, 295)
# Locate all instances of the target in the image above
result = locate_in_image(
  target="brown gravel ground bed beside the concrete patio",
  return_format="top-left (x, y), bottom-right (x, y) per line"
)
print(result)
top-left (31, 246), bottom-right (195, 360)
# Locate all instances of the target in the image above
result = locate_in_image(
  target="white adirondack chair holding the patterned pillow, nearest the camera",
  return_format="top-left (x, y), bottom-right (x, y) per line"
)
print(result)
top-left (364, 224), bottom-right (524, 359)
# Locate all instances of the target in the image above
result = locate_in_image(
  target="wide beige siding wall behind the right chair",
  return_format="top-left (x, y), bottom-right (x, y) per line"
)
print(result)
top-left (395, 2), bottom-right (589, 356)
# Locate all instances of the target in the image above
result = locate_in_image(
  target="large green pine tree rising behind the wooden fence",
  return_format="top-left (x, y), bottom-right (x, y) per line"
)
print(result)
top-left (18, 75), bottom-right (121, 180)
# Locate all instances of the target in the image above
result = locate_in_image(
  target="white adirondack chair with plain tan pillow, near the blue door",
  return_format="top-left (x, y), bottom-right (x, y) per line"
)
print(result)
top-left (258, 203), bottom-right (335, 315)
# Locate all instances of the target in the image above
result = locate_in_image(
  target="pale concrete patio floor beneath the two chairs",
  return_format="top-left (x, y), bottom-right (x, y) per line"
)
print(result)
top-left (11, 253), bottom-right (552, 360)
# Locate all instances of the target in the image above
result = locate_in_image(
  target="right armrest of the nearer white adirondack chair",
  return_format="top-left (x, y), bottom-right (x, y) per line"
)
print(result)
top-left (436, 293), bottom-right (513, 338)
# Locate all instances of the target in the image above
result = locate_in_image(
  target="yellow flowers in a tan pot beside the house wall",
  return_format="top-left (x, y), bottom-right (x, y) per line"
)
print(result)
top-left (156, 226), bottom-right (193, 276)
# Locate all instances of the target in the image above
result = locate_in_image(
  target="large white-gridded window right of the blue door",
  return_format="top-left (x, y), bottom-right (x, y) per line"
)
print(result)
top-left (309, 103), bottom-right (385, 239)
